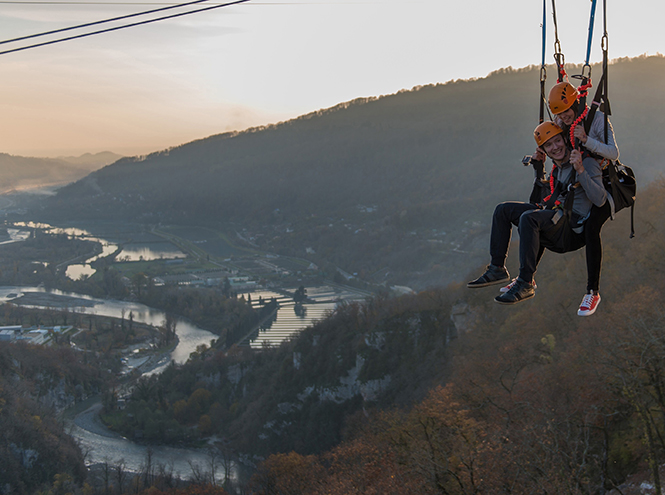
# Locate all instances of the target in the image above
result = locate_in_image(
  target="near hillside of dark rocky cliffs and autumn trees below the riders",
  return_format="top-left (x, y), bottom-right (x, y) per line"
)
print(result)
top-left (122, 181), bottom-right (665, 495)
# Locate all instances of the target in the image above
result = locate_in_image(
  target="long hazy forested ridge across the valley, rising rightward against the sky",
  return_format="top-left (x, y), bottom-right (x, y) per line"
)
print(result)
top-left (42, 56), bottom-right (665, 288)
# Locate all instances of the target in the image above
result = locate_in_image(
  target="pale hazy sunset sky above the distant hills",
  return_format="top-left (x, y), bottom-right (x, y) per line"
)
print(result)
top-left (0, 0), bottom-right (665, 156)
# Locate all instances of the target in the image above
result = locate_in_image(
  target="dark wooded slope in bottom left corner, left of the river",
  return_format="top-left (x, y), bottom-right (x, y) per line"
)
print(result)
top-left (0, 342), bottom-right (103, 494)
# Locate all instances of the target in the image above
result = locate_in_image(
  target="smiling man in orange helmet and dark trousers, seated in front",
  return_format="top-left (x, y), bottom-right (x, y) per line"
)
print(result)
top-left (467, 122), bottom-right (607, 310)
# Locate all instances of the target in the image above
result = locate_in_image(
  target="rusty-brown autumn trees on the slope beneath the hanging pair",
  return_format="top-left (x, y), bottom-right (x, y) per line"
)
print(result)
top-left (249, 184), bottom-right (665, 495)
